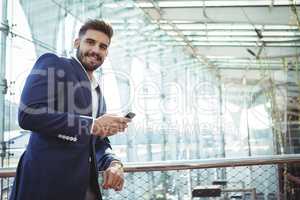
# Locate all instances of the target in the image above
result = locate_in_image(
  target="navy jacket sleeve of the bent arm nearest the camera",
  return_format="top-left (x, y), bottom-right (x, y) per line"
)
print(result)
top-left (18, 54), bottom-right (93, 137)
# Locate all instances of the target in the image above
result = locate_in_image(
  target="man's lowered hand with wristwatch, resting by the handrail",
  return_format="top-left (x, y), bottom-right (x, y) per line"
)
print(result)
top-left (102, 161), bottom-right (124, 191)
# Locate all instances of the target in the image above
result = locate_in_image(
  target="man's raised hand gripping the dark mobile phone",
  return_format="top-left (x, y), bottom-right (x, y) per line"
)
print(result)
top-left (92, 114), bottom-right (131, 138)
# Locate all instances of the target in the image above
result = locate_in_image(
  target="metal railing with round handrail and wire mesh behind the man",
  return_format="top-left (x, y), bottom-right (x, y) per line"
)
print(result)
top-left (0, 154), bottom-right (300, 200)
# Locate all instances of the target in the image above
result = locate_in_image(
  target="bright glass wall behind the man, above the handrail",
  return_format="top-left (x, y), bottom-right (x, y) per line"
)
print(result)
top-left (0, 0), bottom-right (298, 167)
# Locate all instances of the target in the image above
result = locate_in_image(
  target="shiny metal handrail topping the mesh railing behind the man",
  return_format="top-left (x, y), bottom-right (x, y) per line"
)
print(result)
top-left (0, 154), bottom-right (300, 178)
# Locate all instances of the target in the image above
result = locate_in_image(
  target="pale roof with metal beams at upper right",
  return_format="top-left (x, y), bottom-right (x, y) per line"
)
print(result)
top-left (136, 0), bottom-right (300, 79)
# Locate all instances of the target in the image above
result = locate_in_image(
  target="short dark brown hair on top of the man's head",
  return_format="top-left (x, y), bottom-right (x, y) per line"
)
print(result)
top-left (78, 19), bottom-right (114, 41)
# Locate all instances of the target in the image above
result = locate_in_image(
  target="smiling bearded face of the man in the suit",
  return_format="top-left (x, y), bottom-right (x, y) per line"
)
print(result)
top-left (74, 29), bottom-right (110, 71)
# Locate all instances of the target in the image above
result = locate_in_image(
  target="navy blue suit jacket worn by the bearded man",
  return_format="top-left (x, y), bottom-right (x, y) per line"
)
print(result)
top-left (10, 53), bottom-right (114, 200)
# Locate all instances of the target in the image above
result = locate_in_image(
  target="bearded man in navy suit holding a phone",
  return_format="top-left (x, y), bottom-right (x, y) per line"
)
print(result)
top-left (10, 20), bottom-right (130, 200)
